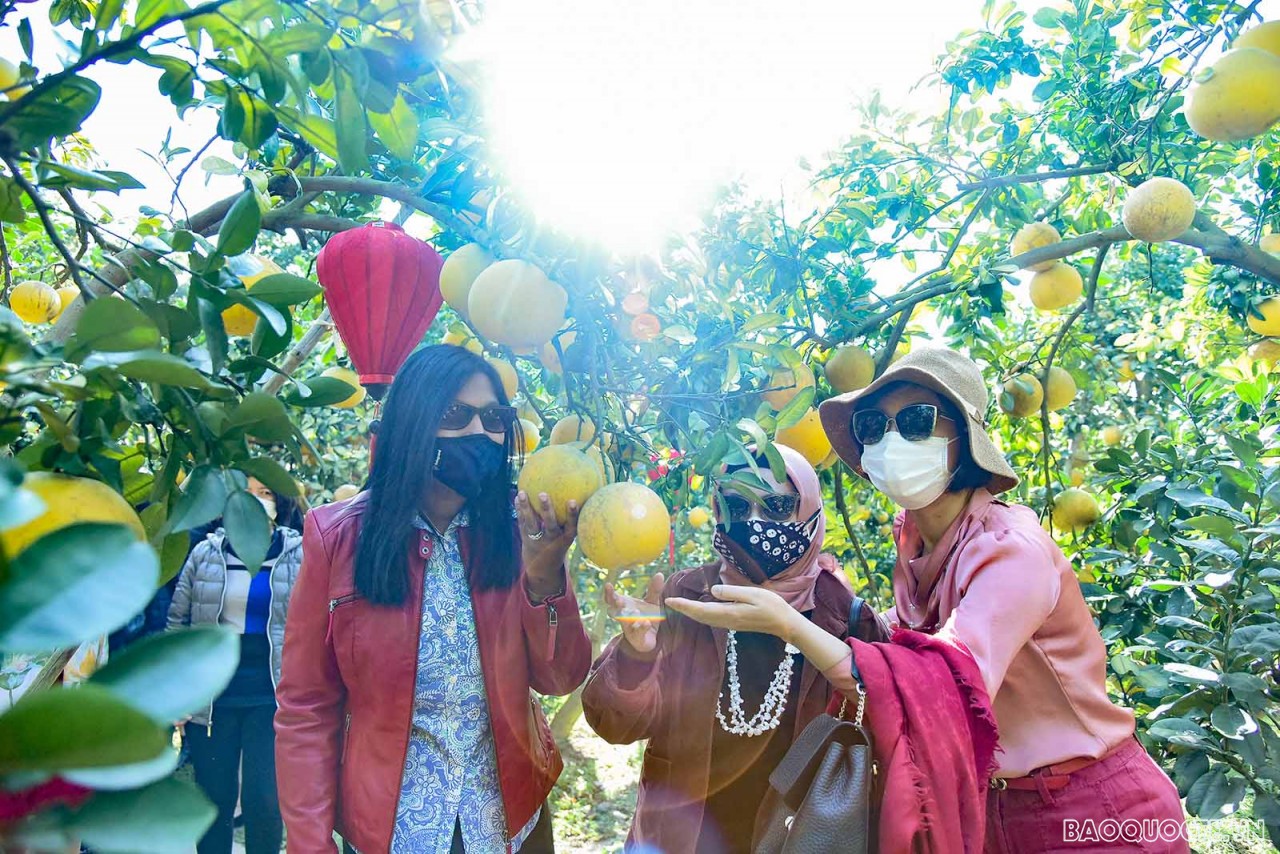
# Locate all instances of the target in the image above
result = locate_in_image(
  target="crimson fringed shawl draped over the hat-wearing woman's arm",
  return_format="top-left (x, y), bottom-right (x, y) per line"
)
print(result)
top-left (828, 627), bottom-right (1000, 854)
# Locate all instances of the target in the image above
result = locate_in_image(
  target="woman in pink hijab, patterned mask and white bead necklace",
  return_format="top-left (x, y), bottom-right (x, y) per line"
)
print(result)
top-left (582, 446), bottom-right (852, 854)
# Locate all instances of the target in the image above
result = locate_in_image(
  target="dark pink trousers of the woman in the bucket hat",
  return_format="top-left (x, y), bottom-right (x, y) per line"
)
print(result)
top-left (983, 739), bottom-right (1190, 854)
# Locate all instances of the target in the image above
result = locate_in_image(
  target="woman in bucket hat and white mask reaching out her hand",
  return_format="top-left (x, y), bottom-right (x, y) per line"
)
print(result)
top-left (667, 348), bottom-right (1189, 853)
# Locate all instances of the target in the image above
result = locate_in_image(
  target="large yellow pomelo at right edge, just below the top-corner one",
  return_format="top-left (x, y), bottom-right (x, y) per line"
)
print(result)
top-left (1183, 47), bottom-right (1280, 142)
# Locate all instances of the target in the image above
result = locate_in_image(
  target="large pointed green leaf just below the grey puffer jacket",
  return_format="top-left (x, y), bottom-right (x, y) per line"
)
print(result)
top-left (88, 624), bottom-right (240, 726)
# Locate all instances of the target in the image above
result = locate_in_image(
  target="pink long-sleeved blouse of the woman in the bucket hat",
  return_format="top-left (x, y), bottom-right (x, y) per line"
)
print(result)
top-left (828, 489), bottom-right (1134, 777)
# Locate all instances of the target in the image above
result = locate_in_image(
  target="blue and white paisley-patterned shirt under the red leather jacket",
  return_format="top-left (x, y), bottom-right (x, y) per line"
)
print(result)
top-left (392, 515), bottom-right (540, 854)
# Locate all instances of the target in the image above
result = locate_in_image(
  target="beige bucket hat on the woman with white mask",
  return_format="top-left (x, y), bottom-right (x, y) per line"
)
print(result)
top-left (818, 347), bottom-right (1018, 494)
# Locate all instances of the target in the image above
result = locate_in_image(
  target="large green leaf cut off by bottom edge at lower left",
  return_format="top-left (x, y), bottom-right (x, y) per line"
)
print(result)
top-left (70, 777), bottom-right (218, 854)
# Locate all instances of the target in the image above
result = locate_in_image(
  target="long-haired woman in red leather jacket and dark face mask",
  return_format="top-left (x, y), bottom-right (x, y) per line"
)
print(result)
top-left (275, 346), bottom-right (591, 854)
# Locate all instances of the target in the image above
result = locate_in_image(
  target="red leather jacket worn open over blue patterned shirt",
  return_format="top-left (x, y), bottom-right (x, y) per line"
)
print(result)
top-left (275, 494), bottom-right (591, 854)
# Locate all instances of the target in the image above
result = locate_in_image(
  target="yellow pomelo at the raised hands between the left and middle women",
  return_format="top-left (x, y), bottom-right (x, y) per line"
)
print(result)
top-left (577, 483), bottom-right (671, 570)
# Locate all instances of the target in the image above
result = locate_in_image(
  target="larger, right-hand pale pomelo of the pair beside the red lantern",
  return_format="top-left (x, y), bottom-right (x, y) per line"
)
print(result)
top-left (467, 260), bottom-right (568, 350)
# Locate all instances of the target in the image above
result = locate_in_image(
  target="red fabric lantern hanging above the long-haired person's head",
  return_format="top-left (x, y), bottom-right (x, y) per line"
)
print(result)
top-left (316, 223), bottom-right (444, 401)
